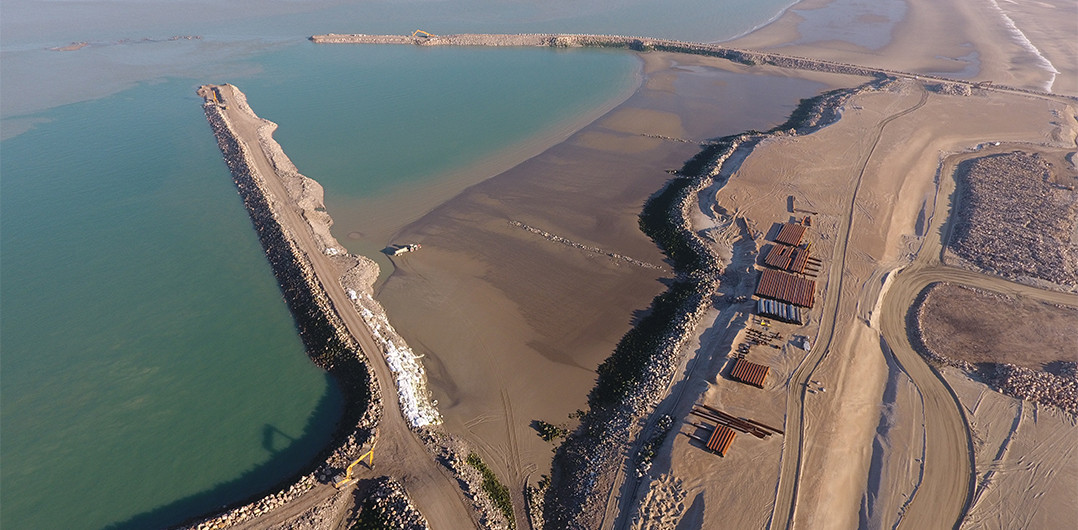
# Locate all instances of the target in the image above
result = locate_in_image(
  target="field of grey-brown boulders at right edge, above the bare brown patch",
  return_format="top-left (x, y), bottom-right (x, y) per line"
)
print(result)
top-left (949, 151), bottom-right (1078, 290)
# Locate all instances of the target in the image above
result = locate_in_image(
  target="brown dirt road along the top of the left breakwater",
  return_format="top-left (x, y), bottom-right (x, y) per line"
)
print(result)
top-left (215, 85), bottom-right (476, 529)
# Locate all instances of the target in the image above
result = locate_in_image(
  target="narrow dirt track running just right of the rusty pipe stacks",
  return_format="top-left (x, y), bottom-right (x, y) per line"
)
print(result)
top-left (770, 87), bottom-right (931, 528)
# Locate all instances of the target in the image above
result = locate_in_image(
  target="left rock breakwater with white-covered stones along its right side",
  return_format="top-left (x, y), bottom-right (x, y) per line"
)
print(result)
top-left (186, 85), bottom-right (509, 530)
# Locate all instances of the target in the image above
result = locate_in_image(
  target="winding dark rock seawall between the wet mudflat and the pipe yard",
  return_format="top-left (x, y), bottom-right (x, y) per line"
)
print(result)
top-left (541, 81), bottom-right (871, 529)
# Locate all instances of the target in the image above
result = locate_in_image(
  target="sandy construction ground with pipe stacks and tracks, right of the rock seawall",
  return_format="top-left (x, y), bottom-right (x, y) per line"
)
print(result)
top-left (638, 71), bottom-right (1078, 528)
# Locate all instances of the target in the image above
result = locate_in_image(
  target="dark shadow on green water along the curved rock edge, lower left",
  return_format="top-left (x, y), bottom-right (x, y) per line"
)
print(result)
top-left (105, 374), bottom-right (344, 530)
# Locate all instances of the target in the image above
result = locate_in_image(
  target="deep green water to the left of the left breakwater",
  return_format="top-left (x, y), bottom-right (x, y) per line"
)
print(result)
top-left (0, 81), bottom-right (341, 528)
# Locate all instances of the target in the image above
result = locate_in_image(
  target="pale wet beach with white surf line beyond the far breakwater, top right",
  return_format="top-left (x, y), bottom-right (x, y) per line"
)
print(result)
top-left (725, 0), bottom-right (1078, 95)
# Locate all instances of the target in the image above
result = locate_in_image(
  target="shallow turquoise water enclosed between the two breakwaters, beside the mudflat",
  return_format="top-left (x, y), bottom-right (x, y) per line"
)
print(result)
top-left (238, 44), bottom-right (639, 200)
